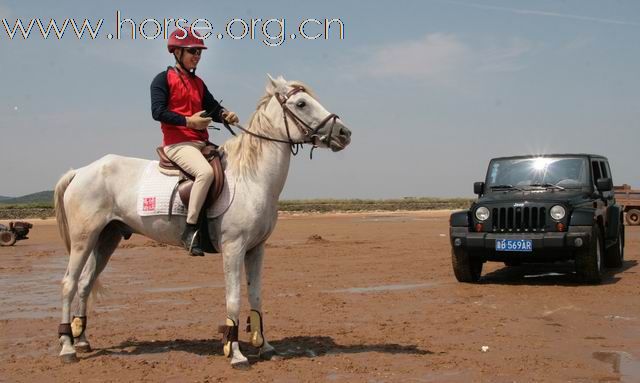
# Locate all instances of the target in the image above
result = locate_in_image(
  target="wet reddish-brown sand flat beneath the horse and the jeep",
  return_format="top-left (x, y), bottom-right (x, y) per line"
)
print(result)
top-left (0, 212), bottom-right (640, 382)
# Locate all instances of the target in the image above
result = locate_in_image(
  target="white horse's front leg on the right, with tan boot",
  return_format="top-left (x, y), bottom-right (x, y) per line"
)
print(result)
top-left (244, 243), bottom-right (276, 360)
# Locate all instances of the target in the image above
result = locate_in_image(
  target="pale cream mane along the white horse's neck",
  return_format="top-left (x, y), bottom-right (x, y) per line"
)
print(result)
top-left (220, 77), bottom-right (316, 176)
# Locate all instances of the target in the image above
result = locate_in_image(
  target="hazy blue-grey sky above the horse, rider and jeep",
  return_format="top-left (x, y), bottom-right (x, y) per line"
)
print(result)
top-left (0, 0), bottom-right (640, 199)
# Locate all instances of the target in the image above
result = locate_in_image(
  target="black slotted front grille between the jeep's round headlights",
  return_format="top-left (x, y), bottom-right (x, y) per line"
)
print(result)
top-left (491, 206), bottom-right (547, 231)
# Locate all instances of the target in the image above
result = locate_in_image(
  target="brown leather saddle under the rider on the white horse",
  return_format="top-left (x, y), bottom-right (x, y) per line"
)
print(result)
top-left (156, 142), bottom-right (224, 253)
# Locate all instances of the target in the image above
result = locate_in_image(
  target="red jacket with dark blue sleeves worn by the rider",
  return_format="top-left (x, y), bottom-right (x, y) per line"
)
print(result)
top-left (151, 67), bottom-right (225, 146)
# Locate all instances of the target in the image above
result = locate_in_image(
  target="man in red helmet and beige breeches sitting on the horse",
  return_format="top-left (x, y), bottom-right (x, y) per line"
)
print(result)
top-left (151, 28), bottom-right (238, 256)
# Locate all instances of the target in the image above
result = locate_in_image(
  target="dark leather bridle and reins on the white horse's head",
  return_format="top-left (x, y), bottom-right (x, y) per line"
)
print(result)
top-left (223, 86), bottom-right (339, 156)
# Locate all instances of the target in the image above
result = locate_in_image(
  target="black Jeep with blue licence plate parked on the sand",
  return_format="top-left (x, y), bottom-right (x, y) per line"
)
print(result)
top-left (450, 154), bottom-right (624, 283)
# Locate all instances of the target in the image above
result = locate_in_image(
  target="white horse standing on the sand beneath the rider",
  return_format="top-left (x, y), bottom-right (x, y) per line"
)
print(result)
top-left (54, 76), bottom-right (351, 368)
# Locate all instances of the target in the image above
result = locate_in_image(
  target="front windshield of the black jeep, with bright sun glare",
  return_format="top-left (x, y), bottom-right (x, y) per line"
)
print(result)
top-left (486, 157), bottom-right (589, 191)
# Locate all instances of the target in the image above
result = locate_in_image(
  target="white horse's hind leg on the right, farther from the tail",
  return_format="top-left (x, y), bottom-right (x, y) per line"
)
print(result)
top-left (71, 223), bottom-right (122, 352)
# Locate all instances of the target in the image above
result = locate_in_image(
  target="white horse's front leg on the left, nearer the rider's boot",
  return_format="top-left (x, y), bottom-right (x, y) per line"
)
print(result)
top-left (219, 241), bottom-right (250, 369)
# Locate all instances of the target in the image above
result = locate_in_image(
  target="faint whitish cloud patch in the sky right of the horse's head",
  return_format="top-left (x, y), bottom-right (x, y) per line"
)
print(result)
top-left (365, 33), bottom-right (470, 79)
